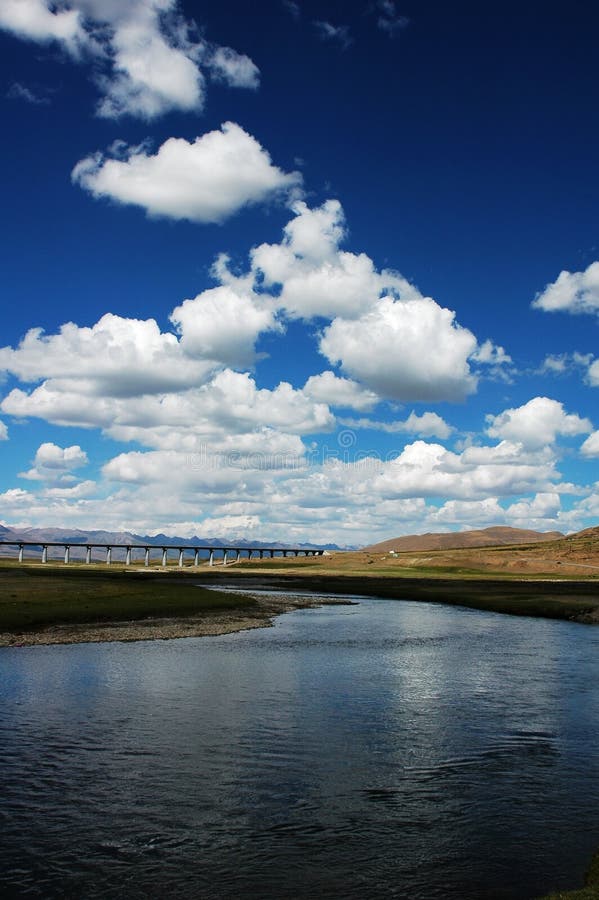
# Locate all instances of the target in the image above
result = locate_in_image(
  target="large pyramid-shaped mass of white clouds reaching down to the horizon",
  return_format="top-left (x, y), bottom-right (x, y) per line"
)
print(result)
top-left (0, 196), bottom-right (540, 543)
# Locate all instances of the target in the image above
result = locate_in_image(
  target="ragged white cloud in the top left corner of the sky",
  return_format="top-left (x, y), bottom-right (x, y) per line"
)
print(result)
top-left (0, 0), bottom-right (259, 120)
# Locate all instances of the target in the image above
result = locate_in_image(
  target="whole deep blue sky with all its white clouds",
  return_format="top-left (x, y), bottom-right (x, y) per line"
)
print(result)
top-left (0, 0), bottom-right (599, 545)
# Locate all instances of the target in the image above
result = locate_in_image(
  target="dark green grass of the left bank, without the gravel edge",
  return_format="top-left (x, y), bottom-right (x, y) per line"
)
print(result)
top-left (0, 564), bottom-right (255, 632)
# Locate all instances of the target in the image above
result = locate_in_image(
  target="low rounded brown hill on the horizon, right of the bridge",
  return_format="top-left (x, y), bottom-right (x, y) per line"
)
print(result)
top-left (364, 525), bottom-right (564, 553)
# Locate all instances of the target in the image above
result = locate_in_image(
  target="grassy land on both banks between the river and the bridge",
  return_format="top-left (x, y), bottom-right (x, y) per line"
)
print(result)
top-left (0, 554), bottom-right (599, 646)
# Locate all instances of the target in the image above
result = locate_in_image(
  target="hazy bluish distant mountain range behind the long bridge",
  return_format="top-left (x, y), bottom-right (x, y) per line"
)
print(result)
top-left (0, 525), bottom-right (355, 555)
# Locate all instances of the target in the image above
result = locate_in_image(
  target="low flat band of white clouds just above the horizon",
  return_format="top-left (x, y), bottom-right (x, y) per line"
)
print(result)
top-left (0, 428), bottom-right (580, 545)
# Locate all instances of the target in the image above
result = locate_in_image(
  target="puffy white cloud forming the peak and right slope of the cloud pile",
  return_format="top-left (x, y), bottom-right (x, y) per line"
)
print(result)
top-left (250, 200), bottom-right (494, 401)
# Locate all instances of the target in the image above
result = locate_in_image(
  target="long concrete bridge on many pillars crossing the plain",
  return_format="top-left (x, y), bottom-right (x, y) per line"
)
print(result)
top-left (0, 541), bottom-right (324, 569)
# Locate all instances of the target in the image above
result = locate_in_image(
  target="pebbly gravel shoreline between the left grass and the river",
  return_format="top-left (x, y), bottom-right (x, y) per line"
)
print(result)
top-left (0, 591), bottom-right (352, 647)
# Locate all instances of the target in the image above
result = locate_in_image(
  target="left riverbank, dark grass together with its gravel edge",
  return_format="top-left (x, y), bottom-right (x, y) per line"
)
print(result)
top-left (0, 566), bottom-right (354, 647)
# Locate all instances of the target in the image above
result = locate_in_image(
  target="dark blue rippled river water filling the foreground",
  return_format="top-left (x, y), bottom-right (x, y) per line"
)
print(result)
top-left (0, 599), bottom-right (599, 900)
